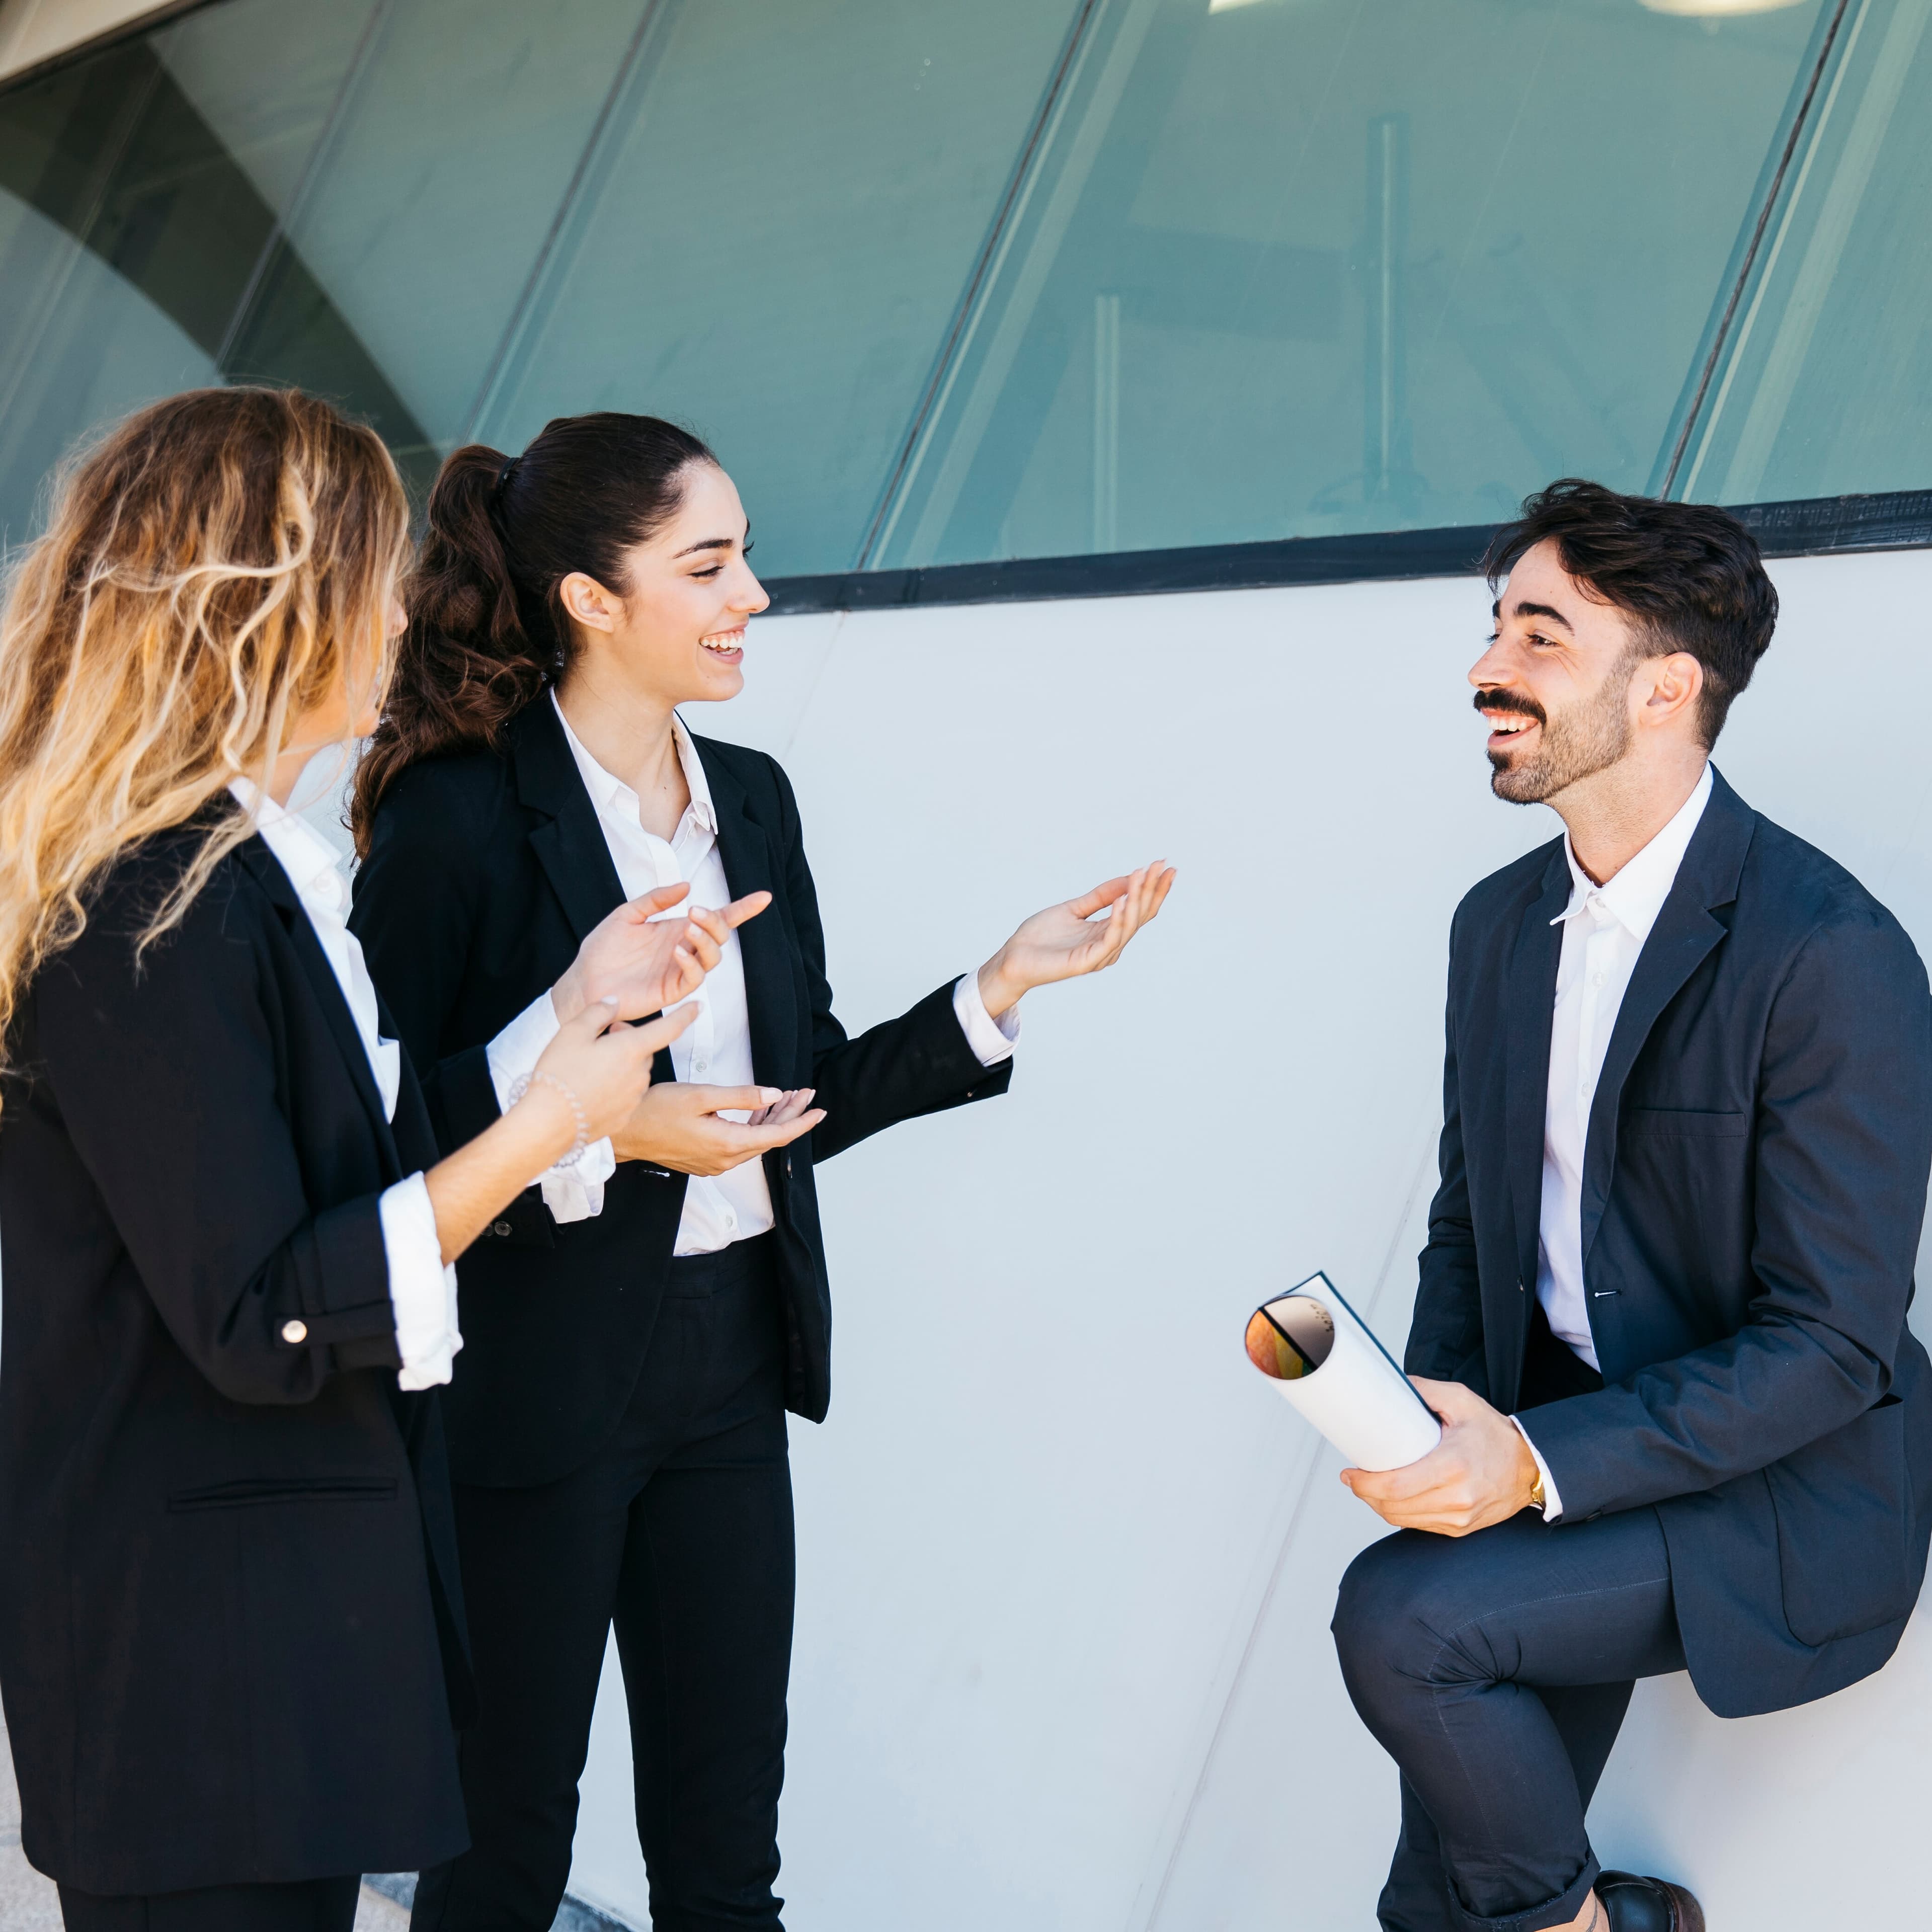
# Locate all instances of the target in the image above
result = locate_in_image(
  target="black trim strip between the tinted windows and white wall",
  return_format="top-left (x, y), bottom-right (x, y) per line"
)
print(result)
top-left (765, 491), bottom-right (1932, 616)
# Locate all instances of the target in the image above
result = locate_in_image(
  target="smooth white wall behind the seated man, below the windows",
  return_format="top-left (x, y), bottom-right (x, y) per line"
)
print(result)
top-left (572, 552), bottom-right (1932, 1932)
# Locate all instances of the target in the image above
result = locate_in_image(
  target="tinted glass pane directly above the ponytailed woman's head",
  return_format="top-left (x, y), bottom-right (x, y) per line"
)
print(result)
top-left (471, 0), bottom-right (1074, 574)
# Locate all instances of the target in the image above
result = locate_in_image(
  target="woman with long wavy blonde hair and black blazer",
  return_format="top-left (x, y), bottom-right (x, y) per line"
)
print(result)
top-left (0, 390), bottom-right (755, 1932)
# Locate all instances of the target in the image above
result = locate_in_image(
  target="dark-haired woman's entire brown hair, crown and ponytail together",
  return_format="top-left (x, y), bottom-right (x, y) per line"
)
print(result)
top-left (350, 410), bottom-right (717, 854)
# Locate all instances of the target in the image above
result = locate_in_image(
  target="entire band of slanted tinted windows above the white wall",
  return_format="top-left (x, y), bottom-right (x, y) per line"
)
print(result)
top-left (0, 0), bottom-right (1932, 576)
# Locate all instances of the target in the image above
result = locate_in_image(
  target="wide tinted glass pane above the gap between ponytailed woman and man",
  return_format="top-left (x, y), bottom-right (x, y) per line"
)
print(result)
top-left (877, 0), bottom-right (1818, 564)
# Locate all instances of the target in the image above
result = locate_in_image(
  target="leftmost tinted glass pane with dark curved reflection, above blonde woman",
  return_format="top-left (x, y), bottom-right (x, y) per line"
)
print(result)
top-left (0, 0), bottom-right (371, 541)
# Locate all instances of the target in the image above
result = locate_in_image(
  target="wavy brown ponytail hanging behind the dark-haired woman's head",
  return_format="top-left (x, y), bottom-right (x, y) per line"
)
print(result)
top-left (350, 442), bottom-right (556, 854)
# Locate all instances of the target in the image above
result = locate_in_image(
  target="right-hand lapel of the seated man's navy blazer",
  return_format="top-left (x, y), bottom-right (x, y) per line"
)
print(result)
top-left (1582, 767), bottom-right (1758, 1267)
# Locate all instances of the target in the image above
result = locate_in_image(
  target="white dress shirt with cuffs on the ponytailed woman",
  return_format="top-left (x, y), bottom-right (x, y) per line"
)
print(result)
top-left (487, 692), bottom-right (1020, 1254)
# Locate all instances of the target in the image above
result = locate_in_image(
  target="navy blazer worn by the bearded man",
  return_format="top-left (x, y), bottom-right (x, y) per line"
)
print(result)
top-left (1407, 761), bottom-right (1932, 1718)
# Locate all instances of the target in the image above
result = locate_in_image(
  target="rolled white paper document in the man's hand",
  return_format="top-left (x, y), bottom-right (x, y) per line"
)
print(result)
top-left (1248, 1275), bottom-right (1443, 1468)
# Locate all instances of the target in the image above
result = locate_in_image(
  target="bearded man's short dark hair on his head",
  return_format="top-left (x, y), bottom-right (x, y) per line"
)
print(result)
top-left (1482, 477), bottom-right (1778, 750)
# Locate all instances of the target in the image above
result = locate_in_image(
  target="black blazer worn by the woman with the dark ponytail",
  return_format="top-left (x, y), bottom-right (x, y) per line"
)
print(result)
top-left (352, 695), bottom-right (1012, 1488)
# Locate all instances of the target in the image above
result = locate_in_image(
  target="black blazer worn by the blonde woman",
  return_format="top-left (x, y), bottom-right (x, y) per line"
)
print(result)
top-left (0, 827), bottom-right (467, 1893)
